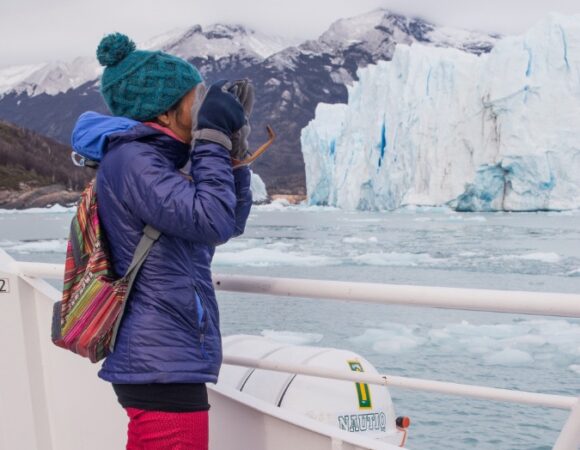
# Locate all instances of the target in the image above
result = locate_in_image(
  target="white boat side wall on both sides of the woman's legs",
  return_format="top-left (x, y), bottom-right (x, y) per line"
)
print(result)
top-left (0, 250), bottom-right (397, 450)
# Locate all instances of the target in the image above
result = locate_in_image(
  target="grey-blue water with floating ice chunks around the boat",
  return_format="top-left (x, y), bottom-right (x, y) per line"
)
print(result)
top-left (0, 205), bottom-right (580, 450)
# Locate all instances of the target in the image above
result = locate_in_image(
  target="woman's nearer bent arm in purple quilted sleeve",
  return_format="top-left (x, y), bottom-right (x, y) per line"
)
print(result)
top-left (125, 141), bottom-right (236, 245)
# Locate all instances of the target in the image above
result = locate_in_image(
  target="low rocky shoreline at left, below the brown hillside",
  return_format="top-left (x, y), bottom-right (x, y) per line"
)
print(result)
top-left (0, 184), bottom-right (81, 209)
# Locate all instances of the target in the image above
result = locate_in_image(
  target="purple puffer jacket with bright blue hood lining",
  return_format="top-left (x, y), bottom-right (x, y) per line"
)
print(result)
top-left (76, 116), bottom-right (252, 384)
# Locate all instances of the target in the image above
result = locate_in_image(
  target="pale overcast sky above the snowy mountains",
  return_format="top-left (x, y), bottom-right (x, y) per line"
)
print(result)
top-left (0, 0), bottom-right (580, 67)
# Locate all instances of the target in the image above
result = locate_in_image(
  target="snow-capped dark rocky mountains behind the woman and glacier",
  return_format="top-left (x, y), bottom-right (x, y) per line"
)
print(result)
top-left (0, 10), bottom-right (498, 193)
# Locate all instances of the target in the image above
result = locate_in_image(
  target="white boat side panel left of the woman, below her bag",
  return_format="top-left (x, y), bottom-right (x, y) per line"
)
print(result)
top-left (0, 249), bottom-right (126, 450)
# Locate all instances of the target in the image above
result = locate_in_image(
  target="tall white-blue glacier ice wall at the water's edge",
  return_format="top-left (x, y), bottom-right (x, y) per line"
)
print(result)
top-left (301, 14), bottom-right (580, 211)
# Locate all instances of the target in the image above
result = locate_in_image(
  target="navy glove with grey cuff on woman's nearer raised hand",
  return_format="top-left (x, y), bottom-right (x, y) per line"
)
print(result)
top-left (194, 80), bottom-right (246, 150)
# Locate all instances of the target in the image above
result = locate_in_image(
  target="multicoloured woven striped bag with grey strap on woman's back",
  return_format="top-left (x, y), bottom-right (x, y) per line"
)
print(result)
top-left (52, 180), bottom-right (160, 363)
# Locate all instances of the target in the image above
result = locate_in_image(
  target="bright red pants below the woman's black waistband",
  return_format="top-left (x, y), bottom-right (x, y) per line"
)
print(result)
top-left (126, 408), bottom-right (209, 450)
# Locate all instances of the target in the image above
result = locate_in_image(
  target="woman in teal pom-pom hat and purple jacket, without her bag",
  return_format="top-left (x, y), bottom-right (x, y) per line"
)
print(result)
top-left (73, 34), bottom-right (252, 450)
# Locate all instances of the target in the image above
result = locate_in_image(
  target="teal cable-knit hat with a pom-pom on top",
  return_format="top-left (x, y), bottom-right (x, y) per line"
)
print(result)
top-left (97, 33), bottom-right (202, 122)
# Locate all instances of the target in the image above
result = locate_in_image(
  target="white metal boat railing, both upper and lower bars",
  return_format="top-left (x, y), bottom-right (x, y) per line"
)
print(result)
top-left (4, 262), bottom-right (580, 450)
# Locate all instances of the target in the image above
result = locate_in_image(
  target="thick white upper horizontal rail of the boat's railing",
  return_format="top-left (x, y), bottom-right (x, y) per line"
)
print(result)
top-left (14, 262), bottom-right (580, 318)
